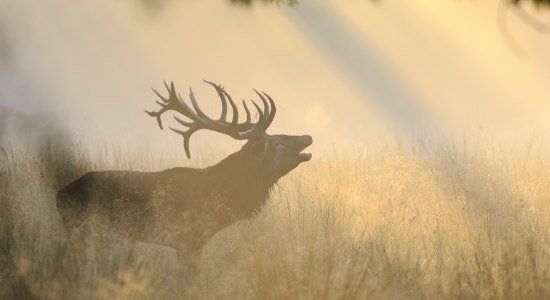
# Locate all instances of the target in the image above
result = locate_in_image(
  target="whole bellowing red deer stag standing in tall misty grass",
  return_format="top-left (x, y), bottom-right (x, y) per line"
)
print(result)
top-left (57, 81), bottom-right (312, 270)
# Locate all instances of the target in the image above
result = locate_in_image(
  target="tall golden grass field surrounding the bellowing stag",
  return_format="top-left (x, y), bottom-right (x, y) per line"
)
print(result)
top-left (0, 139), bottom-right (550, 299)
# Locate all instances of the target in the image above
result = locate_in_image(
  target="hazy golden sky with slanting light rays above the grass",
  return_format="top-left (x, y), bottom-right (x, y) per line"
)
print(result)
top-left (0, 0), bottom-right (550, 159)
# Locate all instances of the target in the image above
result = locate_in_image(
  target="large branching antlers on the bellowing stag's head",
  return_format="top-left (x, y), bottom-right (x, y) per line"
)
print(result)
top-left (145, 80), bottom-right (277, 158)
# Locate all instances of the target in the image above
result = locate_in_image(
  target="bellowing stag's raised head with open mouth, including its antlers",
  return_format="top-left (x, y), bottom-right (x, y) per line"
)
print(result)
top-left (146, 81), bottom-right (313, 181)
